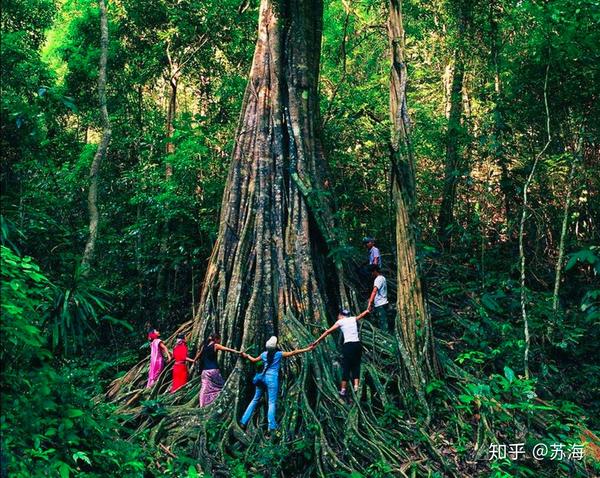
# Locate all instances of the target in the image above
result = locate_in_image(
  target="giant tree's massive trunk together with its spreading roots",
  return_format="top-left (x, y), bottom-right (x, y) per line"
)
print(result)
top-left (109, 0), bottom-right (448, 476)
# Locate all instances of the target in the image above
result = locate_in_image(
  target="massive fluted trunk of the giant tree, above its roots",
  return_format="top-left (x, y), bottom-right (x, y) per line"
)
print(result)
top-left (193, 0), bottom-right (337, 347)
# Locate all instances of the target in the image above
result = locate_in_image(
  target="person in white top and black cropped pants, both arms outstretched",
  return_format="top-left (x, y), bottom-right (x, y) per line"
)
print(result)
top-left (311, 309), bottom-right (369, 398)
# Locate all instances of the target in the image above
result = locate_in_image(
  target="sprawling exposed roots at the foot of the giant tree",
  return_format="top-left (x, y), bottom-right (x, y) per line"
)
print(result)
top-left (107, 317), bottom-right (464, 476)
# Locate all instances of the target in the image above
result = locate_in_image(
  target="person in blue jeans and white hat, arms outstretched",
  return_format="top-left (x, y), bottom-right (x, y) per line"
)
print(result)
top-left (240, 336), bottom-right (314, 432)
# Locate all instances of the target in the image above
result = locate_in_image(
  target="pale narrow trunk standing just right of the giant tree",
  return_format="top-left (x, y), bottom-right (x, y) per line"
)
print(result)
top-left (388, 0), bottom-right (435, 414)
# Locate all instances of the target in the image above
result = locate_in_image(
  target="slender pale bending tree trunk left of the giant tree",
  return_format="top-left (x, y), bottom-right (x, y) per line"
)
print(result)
top-left (80, 0), bottom-right (112, 276)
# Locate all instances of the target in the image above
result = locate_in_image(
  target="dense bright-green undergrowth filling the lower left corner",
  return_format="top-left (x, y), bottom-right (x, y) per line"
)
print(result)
top-left (0, 246), bottom-right (144, 477)
